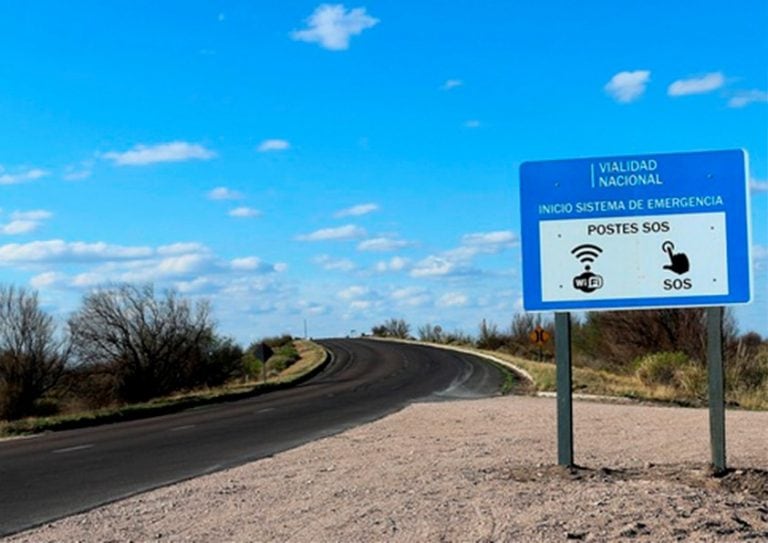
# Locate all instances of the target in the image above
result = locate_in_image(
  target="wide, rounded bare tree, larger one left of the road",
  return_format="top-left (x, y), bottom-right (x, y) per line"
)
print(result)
top-left (69, 284), bottom-right (215, 401)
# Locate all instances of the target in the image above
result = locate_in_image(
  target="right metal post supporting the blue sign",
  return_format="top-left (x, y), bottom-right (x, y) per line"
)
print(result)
top-left (707, 307), bottom-right (727, 475)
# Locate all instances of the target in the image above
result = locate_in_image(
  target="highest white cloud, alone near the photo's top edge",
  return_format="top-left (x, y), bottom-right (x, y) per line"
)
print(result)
top-left (291, 4), bottom-right (379, 51)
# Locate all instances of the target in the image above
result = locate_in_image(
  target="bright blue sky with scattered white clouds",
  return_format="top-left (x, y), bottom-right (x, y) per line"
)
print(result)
top-left (0, 0), bottom-right (768, 342)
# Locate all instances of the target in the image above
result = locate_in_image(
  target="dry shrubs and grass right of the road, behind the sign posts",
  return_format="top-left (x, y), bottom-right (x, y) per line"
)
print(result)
top-left (372, 309), bottom-right (768, 409)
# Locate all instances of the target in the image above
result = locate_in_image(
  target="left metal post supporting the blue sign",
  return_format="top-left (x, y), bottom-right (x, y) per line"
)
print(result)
top-left (555, 313), bottom-right (573, 467)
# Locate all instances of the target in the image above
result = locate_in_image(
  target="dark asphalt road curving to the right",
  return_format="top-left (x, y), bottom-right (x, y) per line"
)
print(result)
top-left (0, 339), bottom-right (503, 536)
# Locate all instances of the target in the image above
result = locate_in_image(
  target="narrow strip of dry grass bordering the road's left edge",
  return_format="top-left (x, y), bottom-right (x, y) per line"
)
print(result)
top-left (0, 340), bottom-right (327, 437)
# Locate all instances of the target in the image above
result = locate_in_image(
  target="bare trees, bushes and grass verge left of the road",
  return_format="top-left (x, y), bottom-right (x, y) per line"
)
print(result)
top-left (0, 284), bottom-right (325, 436)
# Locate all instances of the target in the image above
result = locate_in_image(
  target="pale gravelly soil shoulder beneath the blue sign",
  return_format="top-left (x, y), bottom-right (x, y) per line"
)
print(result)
top-left (7, 397), bottom-right (768, 542)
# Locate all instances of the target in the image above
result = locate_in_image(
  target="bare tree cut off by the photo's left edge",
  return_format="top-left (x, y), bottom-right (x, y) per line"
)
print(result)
top-left (0, 286), bottom-right (69, 419)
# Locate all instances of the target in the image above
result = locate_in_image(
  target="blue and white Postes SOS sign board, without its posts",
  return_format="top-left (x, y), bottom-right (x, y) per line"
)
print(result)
top-left (520, 150), bottom-right (751, 311)
